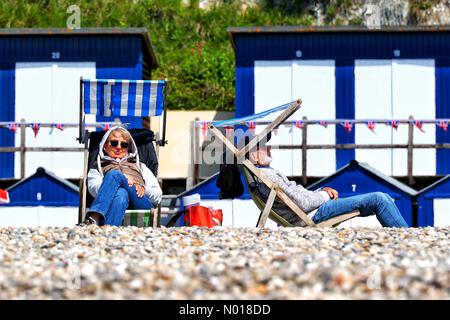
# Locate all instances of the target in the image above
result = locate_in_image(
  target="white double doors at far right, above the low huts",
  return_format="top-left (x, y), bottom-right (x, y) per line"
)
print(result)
top-left (355, 60), bottom-right (436, 176)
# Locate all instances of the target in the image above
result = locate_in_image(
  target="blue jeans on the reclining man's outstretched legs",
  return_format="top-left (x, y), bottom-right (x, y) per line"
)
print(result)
top-left (312, 192), bottom-right (408, 228)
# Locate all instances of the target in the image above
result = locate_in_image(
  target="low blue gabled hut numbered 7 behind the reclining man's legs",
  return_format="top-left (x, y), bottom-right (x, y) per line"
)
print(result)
top-left (308, 160), bottom-right (417, 226)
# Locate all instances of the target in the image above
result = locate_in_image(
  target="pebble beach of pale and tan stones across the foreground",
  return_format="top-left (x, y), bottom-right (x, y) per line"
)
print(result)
top-left (0, 226), bottom-right (450, 299)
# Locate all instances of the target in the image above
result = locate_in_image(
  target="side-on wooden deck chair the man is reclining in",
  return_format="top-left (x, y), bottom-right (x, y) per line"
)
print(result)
top-left (208, 99), bottom-right (360, 228)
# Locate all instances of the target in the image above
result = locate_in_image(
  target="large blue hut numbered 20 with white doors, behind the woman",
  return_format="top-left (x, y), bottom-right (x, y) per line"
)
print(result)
top-left (0, 28), bottom-right (158, 179)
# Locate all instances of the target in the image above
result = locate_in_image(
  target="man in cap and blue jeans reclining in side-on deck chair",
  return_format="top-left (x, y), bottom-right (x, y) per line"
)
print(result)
top-left (240, 133), bottom-right (408, 227)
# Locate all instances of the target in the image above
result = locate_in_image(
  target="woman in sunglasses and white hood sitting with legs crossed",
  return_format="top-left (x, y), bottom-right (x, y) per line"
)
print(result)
top-left (79, 126), bottom-right (162, 226)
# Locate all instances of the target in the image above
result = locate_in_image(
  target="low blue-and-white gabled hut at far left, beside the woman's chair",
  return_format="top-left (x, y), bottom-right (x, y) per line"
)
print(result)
top-left (0, 167), bottom-right (79, 227)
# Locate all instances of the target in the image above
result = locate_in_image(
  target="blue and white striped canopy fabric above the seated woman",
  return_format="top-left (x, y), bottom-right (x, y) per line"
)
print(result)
top-left (83, 79), bottom-right (165, 117)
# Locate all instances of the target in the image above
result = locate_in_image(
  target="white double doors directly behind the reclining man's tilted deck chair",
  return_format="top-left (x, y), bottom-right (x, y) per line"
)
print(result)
top-left (255, 60), bottom-right (336, 176)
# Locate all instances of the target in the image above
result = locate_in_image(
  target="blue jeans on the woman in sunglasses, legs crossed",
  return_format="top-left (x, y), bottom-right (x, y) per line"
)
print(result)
top-left (88, 170), bottom-right (153, 226)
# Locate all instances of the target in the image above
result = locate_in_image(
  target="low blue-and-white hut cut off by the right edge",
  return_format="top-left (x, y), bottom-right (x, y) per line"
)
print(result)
top-left (416, 175), bottom-right (450, 227)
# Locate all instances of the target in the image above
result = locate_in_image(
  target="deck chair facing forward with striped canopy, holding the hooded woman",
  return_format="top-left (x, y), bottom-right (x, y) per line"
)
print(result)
top-left (78, 78), bottom-right (168, 228)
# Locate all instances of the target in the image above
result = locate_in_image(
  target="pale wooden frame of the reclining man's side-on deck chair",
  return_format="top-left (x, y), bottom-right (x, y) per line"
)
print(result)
top-left (208, 99), bottom-right (360, 228)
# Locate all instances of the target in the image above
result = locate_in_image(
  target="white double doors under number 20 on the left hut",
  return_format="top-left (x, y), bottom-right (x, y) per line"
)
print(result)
top-left (14, 62), bottom-right (96, 178)
